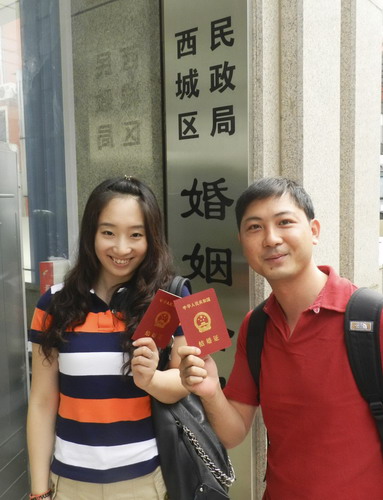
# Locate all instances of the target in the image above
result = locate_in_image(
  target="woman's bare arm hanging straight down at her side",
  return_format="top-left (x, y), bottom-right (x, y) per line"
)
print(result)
top-left (27, 344), bottom-right (59, 493)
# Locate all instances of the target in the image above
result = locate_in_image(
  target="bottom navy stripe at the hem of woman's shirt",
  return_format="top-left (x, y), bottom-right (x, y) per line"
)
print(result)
top-left (51, 456), bottom-right (160, 484)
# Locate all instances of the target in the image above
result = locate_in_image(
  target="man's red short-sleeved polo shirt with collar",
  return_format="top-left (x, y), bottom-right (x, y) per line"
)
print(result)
top-left (225, 266), bottom-right (383, 500)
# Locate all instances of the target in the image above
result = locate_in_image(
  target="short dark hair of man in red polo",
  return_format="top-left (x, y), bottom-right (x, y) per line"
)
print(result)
top-left (235, 177), bottom-right (315, 229)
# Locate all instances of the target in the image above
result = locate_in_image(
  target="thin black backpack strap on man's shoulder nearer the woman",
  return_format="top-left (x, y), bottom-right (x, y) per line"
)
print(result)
top-left (246, 300), bottom-right (267, 402)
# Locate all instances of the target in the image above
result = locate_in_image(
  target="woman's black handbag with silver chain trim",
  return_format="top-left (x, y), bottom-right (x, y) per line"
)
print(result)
top-left (151, 277), bottom-right (235, 500)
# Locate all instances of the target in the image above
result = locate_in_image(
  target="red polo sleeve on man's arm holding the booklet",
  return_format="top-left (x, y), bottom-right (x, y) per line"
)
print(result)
top-left (224, 311), bottom-right (258, 406)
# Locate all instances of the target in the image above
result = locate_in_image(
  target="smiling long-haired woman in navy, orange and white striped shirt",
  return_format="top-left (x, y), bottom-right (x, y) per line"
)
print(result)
top-left (27, 176), bottom-right (188, 500)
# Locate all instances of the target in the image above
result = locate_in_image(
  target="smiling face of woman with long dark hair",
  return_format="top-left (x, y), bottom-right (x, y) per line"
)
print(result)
top-left (94, 195), bottom-right (148, 287)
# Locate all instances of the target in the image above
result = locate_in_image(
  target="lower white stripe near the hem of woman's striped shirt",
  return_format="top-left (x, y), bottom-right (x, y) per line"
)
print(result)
top-left (55, 437), bottom-right (158, 470)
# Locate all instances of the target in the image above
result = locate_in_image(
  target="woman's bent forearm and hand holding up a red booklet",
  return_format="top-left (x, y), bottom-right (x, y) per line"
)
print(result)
top-left (132, 335), bottom-right (188, 403)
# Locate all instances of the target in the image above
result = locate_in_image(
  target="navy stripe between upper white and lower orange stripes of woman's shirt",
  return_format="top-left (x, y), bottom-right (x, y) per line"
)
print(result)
top-left (60, 373), bottom-right (147, 399)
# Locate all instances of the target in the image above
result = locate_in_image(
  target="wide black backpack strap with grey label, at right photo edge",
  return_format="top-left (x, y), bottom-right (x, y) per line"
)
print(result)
top-left (344, 288), bottom-right (383, 444)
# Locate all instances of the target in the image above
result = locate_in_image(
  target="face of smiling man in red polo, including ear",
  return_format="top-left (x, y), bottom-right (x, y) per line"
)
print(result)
top-left (239, 194), bottom-right (320, 286)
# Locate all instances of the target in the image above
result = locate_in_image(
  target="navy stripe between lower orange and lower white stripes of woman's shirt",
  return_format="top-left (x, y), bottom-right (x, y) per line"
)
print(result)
top-left (56, 416), bottom-right (155, 446)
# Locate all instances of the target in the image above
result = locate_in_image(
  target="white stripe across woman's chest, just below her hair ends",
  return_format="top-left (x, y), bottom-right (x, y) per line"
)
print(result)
top-left (59, 352), bottom-right (123, 376)
